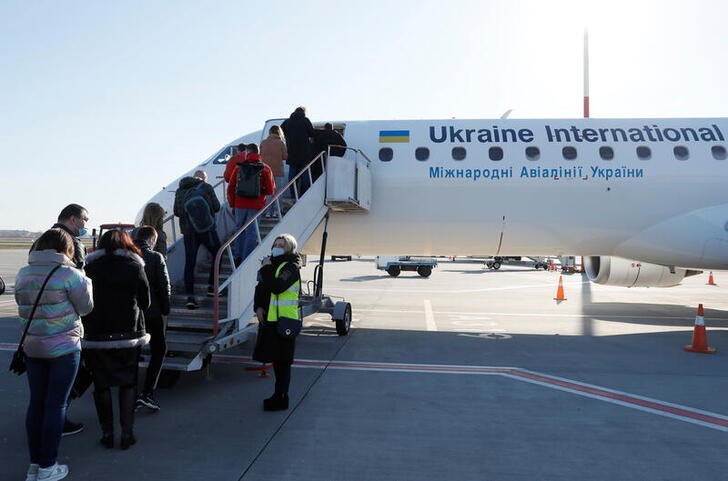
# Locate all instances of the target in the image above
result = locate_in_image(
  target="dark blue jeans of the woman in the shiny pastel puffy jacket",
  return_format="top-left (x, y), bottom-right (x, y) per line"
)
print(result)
top-left (25, 351), bottom-right (81, 468)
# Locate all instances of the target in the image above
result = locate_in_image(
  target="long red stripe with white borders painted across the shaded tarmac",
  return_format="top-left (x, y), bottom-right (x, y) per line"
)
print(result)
top-left (0, 343), bottom-right (728, 432)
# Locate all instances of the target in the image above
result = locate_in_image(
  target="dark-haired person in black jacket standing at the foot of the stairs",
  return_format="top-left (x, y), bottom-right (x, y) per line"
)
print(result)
top-left (134, 225), bottom-right (171, 411)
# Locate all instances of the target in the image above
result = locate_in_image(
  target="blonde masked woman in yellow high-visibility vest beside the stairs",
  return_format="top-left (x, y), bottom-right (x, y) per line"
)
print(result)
top-left (253, 234), bottom-right (301, 411)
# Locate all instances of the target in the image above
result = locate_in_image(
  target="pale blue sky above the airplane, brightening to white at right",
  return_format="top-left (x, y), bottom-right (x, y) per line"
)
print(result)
top-left (0, 0), bottom-right (728, 230)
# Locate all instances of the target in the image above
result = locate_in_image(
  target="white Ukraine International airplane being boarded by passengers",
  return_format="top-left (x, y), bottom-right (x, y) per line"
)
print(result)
top-left (137, 118), bottom-right (728, 376)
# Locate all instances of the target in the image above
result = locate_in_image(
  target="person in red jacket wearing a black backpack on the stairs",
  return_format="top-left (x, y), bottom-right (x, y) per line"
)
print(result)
top-left (227, 144), bottom-right (276, 265)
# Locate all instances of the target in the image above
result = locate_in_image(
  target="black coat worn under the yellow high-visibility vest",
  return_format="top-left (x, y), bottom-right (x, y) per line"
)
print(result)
top-left (253, 254), bottom-right (301, 364)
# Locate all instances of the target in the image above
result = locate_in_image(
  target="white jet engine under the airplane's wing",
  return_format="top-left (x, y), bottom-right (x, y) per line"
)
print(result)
top-left (584, 256), bottom-right (702, 287)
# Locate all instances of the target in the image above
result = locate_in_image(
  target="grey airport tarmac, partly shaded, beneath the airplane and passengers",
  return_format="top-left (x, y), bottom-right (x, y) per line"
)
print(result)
top-left (0, 250), bottom-right (728, 481)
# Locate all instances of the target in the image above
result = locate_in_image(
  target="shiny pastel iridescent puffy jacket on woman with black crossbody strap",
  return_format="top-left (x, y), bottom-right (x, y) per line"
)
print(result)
top-left (15, 250), bottom-right (93, 358)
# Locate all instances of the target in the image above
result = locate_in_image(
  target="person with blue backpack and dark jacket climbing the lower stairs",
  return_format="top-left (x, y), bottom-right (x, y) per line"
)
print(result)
top-left (174, 170), bottom-right (220, 309)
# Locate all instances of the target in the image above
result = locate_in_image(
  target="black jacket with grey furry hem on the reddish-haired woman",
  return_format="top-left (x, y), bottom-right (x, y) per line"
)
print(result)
top-left (82, 249), bottom-right (150, 349)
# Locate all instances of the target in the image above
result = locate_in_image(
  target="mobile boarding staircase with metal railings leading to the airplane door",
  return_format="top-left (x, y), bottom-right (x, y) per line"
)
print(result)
top-left (142, 147), bottom-right (371, 378)
